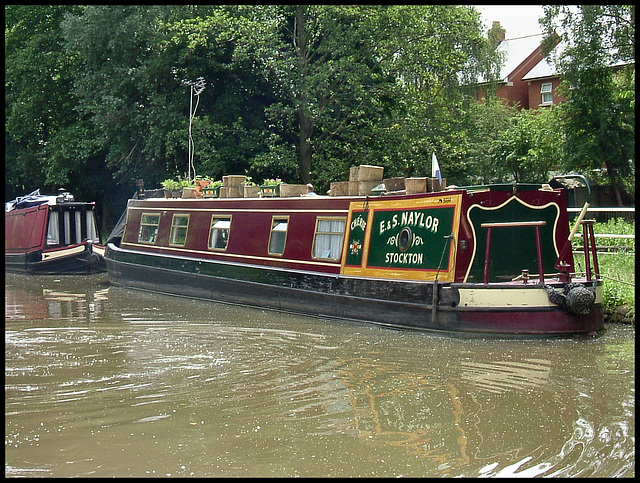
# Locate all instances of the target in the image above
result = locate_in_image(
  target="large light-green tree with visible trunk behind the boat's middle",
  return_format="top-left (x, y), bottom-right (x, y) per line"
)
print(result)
top-left (174, 5), bottom-right (498, 187)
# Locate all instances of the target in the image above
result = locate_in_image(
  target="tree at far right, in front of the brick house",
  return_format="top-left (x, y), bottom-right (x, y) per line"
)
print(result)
top-left (543, 5), bottom-right (635, 205)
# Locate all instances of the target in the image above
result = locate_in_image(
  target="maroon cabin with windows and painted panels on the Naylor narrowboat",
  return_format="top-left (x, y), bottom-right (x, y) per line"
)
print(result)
top-left (121, 184), bottom-right (573, 283)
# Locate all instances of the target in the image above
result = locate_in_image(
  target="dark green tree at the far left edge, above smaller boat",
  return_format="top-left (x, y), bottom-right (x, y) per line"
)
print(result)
top-left (5, 5), bottom-right (78, 197)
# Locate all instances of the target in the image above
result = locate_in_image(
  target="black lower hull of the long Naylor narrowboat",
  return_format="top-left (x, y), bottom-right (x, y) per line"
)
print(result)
top-left (106, 244), bottom-right (602, 336)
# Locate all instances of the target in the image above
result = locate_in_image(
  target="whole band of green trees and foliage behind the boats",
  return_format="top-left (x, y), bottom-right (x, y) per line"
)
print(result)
top-left (5, 5), bottom-right (635, 231)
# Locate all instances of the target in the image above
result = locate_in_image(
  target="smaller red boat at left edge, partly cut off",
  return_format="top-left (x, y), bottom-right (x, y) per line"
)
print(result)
top-left (4, 190), bottom-right (106, 275)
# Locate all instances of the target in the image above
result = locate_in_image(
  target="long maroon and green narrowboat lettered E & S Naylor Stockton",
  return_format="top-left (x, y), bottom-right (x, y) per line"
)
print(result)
top-left (105, 176), bottom-right (604, 336)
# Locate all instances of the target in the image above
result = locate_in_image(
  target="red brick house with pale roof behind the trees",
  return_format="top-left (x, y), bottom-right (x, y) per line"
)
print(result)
top-left (476, 22), bottom-right (565, 109)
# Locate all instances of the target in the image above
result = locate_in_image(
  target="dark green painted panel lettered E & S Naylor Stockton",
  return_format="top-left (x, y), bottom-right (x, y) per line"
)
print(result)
top-left (367, 206), bottom-right (455, 270)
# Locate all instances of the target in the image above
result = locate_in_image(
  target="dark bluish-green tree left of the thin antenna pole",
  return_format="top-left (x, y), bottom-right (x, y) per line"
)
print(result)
top-left (61, 5), bottom-right (188, 183)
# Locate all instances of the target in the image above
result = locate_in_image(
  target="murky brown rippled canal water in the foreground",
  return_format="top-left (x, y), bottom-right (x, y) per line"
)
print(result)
top-left (5, 274), bottom-right (635, 477)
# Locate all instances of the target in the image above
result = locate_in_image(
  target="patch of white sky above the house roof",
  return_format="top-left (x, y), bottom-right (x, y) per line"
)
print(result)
top-left (474, 5), bottom-right (542, 39)
